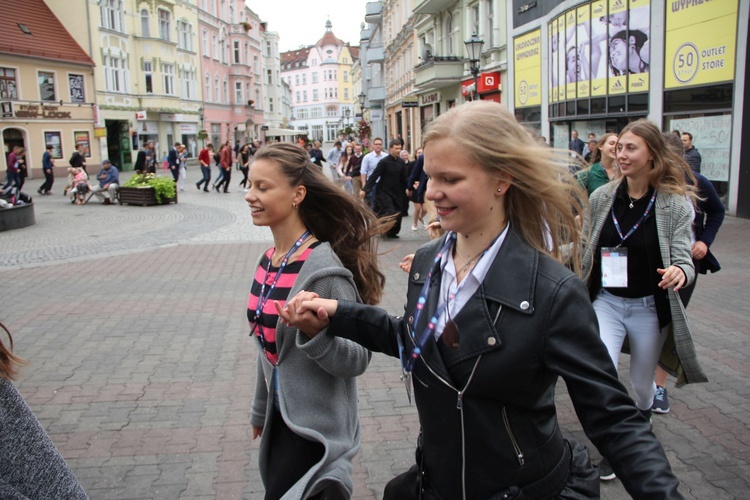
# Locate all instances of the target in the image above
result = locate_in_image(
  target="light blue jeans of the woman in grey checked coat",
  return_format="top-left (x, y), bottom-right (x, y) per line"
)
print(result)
top-left (594, 290), bottom-right (666, 410)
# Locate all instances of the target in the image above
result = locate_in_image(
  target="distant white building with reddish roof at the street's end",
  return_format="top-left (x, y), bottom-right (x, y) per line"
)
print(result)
top-left (281, 20), bottom-right (357, 147)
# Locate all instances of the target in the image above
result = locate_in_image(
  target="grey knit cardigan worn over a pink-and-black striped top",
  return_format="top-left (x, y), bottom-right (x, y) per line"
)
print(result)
top-left (250, 242), bottom-right (372, 500)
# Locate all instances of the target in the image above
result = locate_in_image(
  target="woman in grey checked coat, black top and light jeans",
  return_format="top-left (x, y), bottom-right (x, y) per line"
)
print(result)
top-left (583, 120), bottom-right (707, 480)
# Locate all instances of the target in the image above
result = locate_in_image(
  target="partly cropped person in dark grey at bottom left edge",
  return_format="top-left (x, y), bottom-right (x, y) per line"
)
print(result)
top-left (0, 323), bottom-right (88, 500)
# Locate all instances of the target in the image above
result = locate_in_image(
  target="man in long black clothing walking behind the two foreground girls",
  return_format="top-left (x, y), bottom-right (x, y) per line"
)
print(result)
top-left (359, 139), bottom-right (408, 238)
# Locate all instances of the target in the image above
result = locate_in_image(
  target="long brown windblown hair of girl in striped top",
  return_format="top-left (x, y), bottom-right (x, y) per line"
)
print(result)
top-left (255, 142), bottom-right (392, 304)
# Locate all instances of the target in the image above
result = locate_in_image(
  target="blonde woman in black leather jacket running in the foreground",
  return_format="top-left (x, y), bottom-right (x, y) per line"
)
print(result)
top-left (279, 100), bottom-right (682, 499)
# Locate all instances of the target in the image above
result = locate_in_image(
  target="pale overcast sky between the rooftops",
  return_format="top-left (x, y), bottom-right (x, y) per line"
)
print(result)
top-left (251, 0), bottom-right (367, 52)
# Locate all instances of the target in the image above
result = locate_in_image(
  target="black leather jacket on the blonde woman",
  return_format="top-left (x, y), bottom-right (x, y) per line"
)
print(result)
top-left (329, 227), bottom-right (681, 499)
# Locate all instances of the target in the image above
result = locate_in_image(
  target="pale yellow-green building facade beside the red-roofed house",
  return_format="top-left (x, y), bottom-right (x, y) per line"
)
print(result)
top-left (48, 0), bottom-right (203, 170)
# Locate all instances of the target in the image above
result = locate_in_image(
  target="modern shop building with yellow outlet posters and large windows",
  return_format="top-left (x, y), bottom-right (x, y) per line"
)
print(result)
top-left (507, 0), bottom-right (750, 217)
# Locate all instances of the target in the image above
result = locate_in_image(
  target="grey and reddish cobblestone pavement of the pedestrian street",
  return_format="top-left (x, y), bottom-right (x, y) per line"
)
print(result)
top-left (0, 172), bottom-right (750, 500)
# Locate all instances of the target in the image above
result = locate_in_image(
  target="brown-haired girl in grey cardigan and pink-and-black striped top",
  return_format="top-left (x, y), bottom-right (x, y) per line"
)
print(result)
top-left (245, 143), bottom-right (385, 499)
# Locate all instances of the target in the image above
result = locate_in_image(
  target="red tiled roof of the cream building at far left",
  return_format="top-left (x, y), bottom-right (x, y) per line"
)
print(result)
top-left (0, 0), bottom-right (94, 66)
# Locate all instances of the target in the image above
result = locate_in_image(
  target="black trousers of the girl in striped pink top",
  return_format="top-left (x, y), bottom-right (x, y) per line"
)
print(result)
top-left (265, 410), bottom-right (325, 500)
